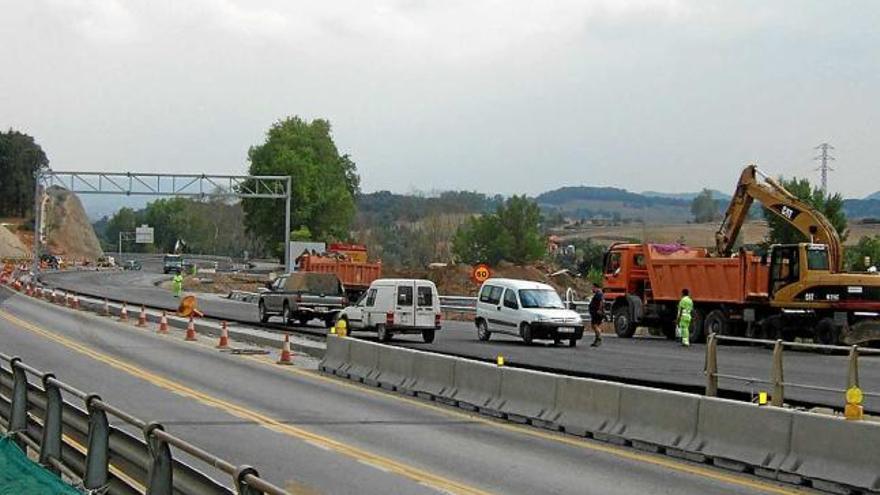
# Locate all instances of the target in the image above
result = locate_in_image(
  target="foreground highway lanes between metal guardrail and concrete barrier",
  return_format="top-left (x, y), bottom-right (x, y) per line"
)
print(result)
top-left (0, 290), bottom-right (802, 494)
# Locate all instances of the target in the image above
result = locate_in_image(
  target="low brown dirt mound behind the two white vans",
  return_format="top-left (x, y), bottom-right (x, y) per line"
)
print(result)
top-left (382, 262), bottom-right (592, 298)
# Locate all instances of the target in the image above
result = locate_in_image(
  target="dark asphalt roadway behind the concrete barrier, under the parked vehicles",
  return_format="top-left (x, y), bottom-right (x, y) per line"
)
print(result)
top-left (44, 272), bottom-right (880, 413)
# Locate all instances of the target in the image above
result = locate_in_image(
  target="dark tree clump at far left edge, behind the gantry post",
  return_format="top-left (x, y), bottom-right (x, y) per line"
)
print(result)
top-left (0, 129), bottom-right (49, 217)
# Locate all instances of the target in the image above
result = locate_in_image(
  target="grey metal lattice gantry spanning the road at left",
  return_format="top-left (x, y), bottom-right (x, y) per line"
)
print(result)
top-left (34, 170), bottom-right (292, 273)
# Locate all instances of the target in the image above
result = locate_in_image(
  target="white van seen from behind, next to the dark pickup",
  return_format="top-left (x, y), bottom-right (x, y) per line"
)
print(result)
top-left (339, 278), bottom-right (440, 343)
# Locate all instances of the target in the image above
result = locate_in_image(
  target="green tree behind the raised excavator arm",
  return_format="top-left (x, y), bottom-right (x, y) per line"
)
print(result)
top-left (764, 177), bottom-right (849, 244)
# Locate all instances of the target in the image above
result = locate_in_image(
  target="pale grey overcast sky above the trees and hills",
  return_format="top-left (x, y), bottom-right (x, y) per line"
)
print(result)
top-left (0, 0), bottom-right (880, 202)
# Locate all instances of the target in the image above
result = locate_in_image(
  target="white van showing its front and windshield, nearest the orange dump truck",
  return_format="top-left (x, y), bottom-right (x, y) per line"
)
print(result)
top-left (474, 278), bottom-right (584, 347)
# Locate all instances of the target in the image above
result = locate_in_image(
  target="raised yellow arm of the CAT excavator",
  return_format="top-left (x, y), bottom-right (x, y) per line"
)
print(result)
top-left (715, 165), bottom-right (842, 272)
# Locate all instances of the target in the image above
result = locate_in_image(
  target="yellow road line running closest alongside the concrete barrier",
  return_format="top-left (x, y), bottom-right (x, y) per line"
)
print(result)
top-left (0, 290), bottom-right (806, 495)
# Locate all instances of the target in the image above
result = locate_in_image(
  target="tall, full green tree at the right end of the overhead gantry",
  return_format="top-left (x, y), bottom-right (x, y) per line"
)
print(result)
top-left (242, 117), bottom-right (360, 258)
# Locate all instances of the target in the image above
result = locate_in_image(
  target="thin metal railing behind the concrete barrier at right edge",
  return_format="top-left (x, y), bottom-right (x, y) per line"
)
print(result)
top-left (705, 333), bottom-right (880, 407)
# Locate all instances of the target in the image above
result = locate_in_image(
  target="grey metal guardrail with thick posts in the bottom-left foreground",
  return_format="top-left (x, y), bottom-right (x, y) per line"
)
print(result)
top-left (0, 353), bottom-right (289, 495)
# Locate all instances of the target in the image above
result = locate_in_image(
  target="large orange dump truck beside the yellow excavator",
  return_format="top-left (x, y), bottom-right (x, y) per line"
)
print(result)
top-left (604, 244), bottom-right (770, 341)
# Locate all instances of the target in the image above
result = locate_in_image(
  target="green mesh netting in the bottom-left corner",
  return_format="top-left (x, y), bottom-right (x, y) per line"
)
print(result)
top-left (0, 437), bottom-right (82, 495)
